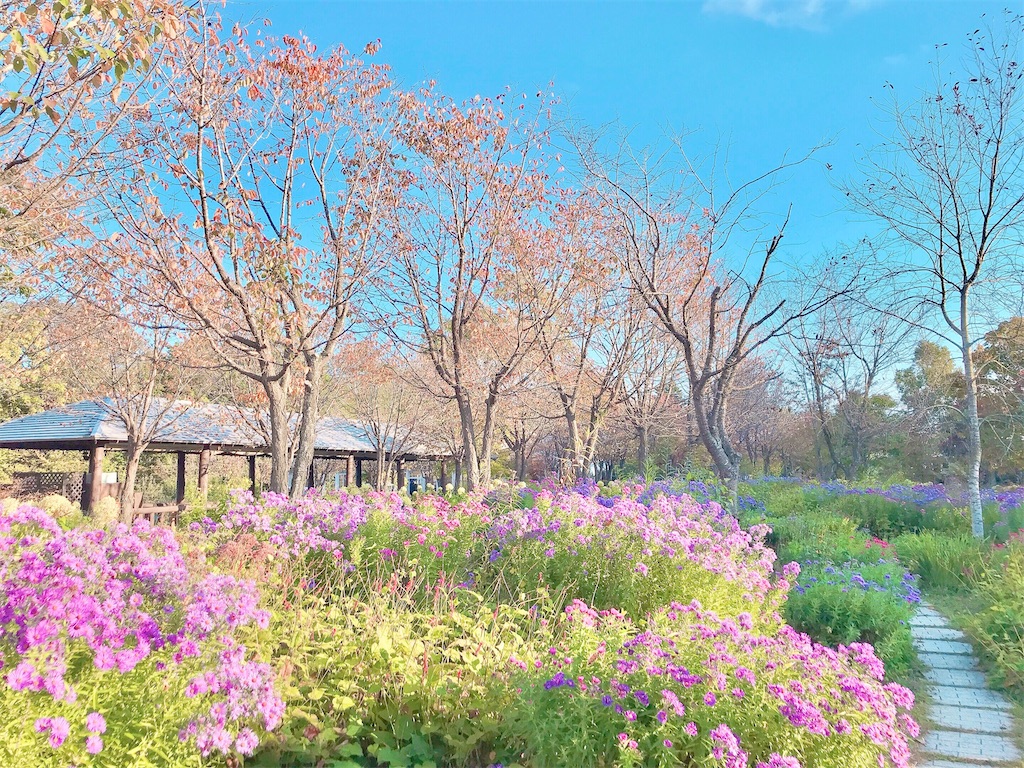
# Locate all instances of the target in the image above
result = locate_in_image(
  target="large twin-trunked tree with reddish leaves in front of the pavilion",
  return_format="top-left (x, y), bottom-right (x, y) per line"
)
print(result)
top-left (89, 17), bottom-right (394, 495)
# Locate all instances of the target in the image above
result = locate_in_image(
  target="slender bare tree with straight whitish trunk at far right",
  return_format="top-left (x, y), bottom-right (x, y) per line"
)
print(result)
top-left (846, 16), bottom-right (1024, 537)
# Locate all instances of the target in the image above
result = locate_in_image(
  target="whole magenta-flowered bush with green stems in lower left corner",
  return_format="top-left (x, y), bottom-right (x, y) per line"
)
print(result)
top-left (0, 506), bottom-right (281, 767)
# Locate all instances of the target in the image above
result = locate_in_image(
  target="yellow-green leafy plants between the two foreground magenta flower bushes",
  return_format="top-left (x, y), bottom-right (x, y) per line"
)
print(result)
top-left (238, 554), bottom-right (536, 768)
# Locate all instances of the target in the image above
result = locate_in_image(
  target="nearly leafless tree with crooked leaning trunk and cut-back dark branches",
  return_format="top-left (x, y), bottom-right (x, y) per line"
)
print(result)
top-left (577, 132), bottom-right (842, 498)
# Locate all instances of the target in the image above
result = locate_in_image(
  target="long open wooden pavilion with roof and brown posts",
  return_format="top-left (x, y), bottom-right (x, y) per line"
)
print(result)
top-left (0, 400), bottom-right (446, 514)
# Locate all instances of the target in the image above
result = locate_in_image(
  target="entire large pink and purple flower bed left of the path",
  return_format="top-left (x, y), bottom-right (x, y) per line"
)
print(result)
top-left (0, 484), bottom-right (915, 768)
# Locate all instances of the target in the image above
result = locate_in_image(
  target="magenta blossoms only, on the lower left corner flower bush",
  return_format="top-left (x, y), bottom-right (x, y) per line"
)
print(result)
top-left (0, 506), bottom-right (283, 754)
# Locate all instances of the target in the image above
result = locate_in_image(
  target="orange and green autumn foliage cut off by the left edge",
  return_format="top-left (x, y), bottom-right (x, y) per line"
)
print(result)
top-left (0, 0), bottom-right (187, 409)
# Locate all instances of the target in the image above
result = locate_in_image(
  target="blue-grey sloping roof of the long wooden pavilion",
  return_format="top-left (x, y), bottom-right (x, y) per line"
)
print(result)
top-left (0, 398), bottom-right (440, 460)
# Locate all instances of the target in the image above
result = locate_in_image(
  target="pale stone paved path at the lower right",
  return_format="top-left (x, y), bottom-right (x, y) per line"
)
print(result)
top-left (910, 604), bottom-right (1022, 768)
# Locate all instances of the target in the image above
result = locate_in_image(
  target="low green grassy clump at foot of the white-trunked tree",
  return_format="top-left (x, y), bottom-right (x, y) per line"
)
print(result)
top-left (892, 530), bottom-right (988, 589)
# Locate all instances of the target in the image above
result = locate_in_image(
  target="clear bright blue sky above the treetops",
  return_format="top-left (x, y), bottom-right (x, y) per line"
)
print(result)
top-left (225, 0), bottom-right (1024, 260)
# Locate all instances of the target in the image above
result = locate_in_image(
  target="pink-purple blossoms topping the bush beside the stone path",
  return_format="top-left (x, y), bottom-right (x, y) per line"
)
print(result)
top-left (535, 601), bottom-right (919, 768)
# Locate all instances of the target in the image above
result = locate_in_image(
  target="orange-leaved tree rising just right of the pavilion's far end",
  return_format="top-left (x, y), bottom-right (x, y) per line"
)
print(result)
top-left (379, 89), bottom-right (573, 489)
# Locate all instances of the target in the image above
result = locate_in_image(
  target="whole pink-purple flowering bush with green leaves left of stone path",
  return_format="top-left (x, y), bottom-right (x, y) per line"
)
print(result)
top-left (507, 603), bottom-right (918, 768)
